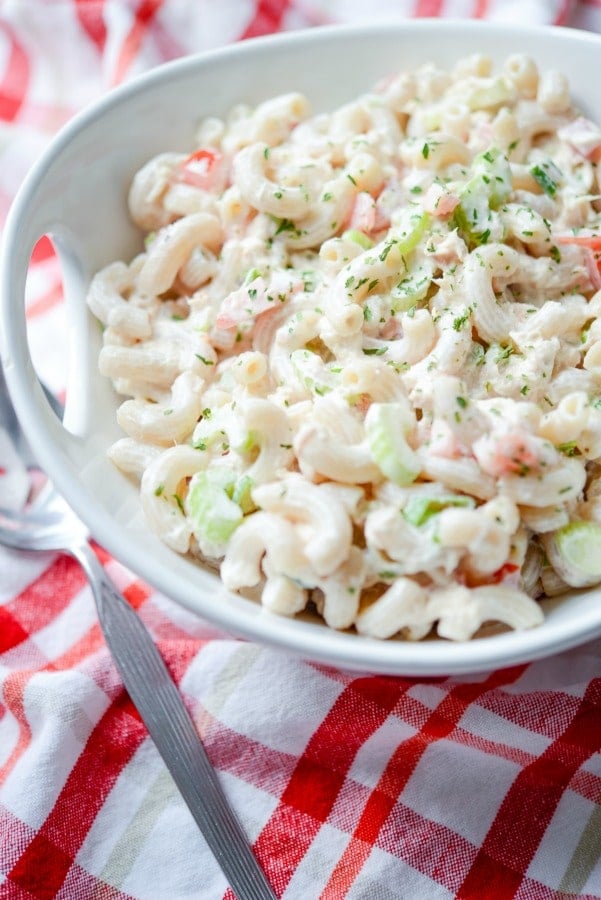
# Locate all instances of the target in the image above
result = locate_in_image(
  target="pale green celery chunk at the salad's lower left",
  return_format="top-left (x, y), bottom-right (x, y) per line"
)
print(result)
top-left (185, 468), bottom-right (243, 545)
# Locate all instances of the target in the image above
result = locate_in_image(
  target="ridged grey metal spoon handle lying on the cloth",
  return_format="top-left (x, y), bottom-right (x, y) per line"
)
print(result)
top-left (71, 543), bottom-right (276, 900)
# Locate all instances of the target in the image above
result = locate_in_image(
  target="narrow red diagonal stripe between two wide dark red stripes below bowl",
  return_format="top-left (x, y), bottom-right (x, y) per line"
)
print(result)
top-left (321, 666), bottom-right (525, 900)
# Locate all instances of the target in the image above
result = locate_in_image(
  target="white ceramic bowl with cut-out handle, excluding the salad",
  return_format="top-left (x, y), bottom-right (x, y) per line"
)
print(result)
top-left (1, 20), bottom-right (601, 676)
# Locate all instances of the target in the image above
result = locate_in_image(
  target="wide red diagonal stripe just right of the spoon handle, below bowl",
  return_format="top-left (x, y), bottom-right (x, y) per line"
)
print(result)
top-left (254, 676), bottom-right (410, 892)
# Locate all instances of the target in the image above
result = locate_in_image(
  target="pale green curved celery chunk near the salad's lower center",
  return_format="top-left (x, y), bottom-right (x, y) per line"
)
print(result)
top-left (365, 403), bottom-right (420, 486)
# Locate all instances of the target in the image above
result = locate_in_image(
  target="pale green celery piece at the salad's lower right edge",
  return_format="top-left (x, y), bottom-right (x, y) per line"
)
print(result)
top-left (544, 521), bottom-right (601, 587)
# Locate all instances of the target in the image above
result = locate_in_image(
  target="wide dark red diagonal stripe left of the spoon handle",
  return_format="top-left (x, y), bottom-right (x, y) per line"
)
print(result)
top-left (8, 690), bottom-right (146, 898)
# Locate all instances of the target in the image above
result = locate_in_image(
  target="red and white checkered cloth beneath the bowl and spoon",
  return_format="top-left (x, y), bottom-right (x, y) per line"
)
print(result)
top-left (0, 0), bottom-right (601, 900)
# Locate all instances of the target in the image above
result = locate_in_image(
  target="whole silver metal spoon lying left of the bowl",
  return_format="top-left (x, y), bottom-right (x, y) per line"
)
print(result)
top-left (0, 367), bottom-right (275, 900)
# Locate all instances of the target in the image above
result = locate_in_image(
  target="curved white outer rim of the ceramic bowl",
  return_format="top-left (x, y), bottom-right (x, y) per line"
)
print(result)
top-left (0, 18), bottom-right (601, 676)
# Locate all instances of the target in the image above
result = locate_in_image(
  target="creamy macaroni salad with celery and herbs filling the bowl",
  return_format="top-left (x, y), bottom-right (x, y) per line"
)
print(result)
top-left (88, 55), bottom-right (601, 640)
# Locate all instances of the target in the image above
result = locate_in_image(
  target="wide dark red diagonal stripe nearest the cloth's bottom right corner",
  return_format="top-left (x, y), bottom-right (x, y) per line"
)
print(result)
top-left (457, 678), bottom-right (601, 900)
